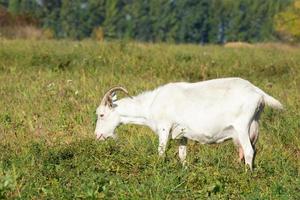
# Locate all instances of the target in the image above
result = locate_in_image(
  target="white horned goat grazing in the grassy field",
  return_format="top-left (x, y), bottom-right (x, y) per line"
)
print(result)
top-left (95, 78), bottom-right (282, 169)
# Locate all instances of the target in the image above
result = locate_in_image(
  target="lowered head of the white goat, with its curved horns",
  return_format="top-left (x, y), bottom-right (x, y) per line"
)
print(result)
top-left (95, 86), bottom-right (129, 140)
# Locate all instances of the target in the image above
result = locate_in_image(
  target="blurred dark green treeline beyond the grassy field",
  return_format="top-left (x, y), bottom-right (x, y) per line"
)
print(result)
top-left (0, 0), bottom-right (300, 43)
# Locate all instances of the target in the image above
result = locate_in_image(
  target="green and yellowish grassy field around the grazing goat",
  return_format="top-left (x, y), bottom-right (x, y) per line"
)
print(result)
top-left (0, 40), bottom-right (300, 199)
